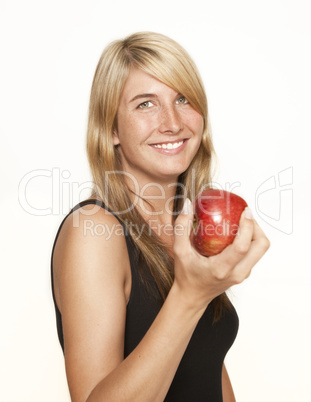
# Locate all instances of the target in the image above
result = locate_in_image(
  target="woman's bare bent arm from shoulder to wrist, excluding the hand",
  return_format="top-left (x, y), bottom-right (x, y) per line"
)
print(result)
top-left (54, 207), bottom-right (204, 402)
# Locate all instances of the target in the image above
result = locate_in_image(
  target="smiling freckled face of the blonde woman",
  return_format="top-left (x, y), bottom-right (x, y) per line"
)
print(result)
top-left (114, 69), bottom-right (203, 184)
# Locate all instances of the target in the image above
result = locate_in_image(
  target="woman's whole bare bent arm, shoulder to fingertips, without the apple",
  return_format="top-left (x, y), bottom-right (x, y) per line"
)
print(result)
top-left (55, 203), bottom-right (268, 402)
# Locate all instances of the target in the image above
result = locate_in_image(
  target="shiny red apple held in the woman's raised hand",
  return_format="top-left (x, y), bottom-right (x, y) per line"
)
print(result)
top-left (190, 189), bottom-right (247, 256)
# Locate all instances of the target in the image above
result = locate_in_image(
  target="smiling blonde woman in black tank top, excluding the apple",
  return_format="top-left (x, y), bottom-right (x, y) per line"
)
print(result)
top-left (51, 32), bottom-right (269, 402)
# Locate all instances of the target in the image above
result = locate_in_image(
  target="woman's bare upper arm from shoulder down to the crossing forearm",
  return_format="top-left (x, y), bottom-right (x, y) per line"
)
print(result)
top-left (53, 204), bottom-right (131, 401)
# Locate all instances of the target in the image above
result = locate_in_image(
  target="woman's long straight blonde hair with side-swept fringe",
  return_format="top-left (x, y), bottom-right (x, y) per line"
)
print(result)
top-left (87, 32), bottom-right (230, 320)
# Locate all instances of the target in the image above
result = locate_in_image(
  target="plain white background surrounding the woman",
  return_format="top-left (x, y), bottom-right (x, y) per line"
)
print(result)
top-left (0, 0), bottom-right (311, 402)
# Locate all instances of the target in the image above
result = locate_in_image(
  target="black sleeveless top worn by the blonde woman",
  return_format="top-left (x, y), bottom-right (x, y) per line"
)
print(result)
top-left (51, 199), bottom-right (239, 402)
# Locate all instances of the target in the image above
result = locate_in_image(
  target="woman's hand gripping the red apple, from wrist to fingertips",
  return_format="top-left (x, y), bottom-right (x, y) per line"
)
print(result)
top-left (173, 200), bottom-right (270, 308)
